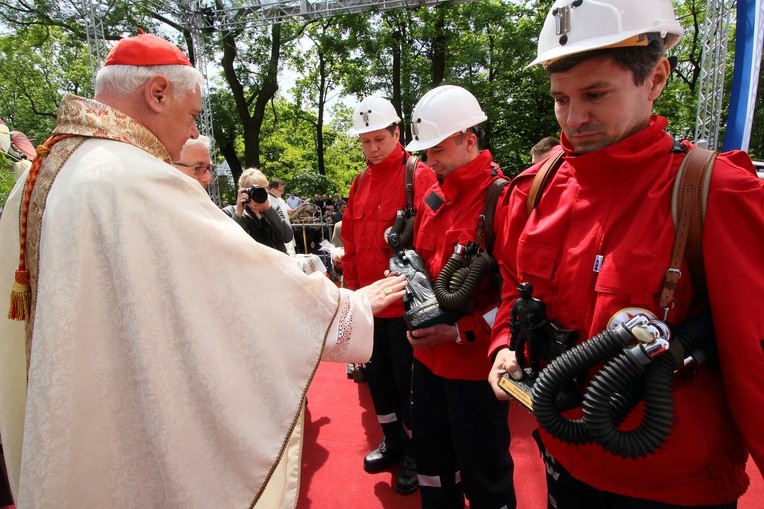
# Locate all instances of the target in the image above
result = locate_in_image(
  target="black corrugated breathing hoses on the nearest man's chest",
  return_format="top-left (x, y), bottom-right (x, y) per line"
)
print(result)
top-left (532, 313), bottom-right (716, 458)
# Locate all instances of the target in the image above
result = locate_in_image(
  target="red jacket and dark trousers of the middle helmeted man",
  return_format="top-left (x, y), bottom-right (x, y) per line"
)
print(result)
top-left (412, 150), bottom-right (515, 509)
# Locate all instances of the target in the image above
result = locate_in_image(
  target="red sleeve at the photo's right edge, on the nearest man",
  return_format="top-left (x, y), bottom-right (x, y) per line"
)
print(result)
top-left (703, 152), bottom-right (764, 472)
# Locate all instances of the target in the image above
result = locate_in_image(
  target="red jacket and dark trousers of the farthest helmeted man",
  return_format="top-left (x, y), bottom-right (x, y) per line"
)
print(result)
top-left (342, 143), bottom-right (437, 462)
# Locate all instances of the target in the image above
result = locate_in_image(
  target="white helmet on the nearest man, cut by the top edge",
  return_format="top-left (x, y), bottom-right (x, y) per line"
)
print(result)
top-left (528, 0), bottom-right (684, 67)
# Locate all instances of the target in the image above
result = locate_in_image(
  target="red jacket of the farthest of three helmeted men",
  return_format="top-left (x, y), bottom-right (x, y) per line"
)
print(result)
top-left (342, 143), bottom-right (437, 318)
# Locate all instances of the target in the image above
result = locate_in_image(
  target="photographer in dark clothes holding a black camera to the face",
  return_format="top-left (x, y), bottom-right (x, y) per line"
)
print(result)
top-left (223, 168), bottom-right (294, 253)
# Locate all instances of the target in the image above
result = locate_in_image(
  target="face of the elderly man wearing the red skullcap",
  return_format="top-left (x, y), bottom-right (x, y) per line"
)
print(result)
top-left (160, 88), bottom-right (202, 161)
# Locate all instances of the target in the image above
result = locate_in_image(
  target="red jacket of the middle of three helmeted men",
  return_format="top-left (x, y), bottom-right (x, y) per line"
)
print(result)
top-left (414, 150), bottom-right (509, 380)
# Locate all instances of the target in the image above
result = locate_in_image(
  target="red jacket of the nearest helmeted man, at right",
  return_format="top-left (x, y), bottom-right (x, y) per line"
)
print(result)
top-left (490, 116), bottom-right (764, 505)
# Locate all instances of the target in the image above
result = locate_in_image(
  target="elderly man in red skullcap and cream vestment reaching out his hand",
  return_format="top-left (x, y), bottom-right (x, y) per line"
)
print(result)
top-left (0, 34), bottom-right (405, 509)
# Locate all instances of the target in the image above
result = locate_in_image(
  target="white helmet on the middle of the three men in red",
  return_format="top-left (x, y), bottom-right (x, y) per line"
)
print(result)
top-left (406, 85), bottom-right (488, 152)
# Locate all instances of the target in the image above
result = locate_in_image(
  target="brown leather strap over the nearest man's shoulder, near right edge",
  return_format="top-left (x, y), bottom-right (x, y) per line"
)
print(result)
top-left (660, 147), bottom-right (716, 310)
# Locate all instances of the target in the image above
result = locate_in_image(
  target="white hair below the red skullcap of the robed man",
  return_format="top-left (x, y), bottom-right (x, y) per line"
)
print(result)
top-left (95, 65), bottom-right (204, 94)
